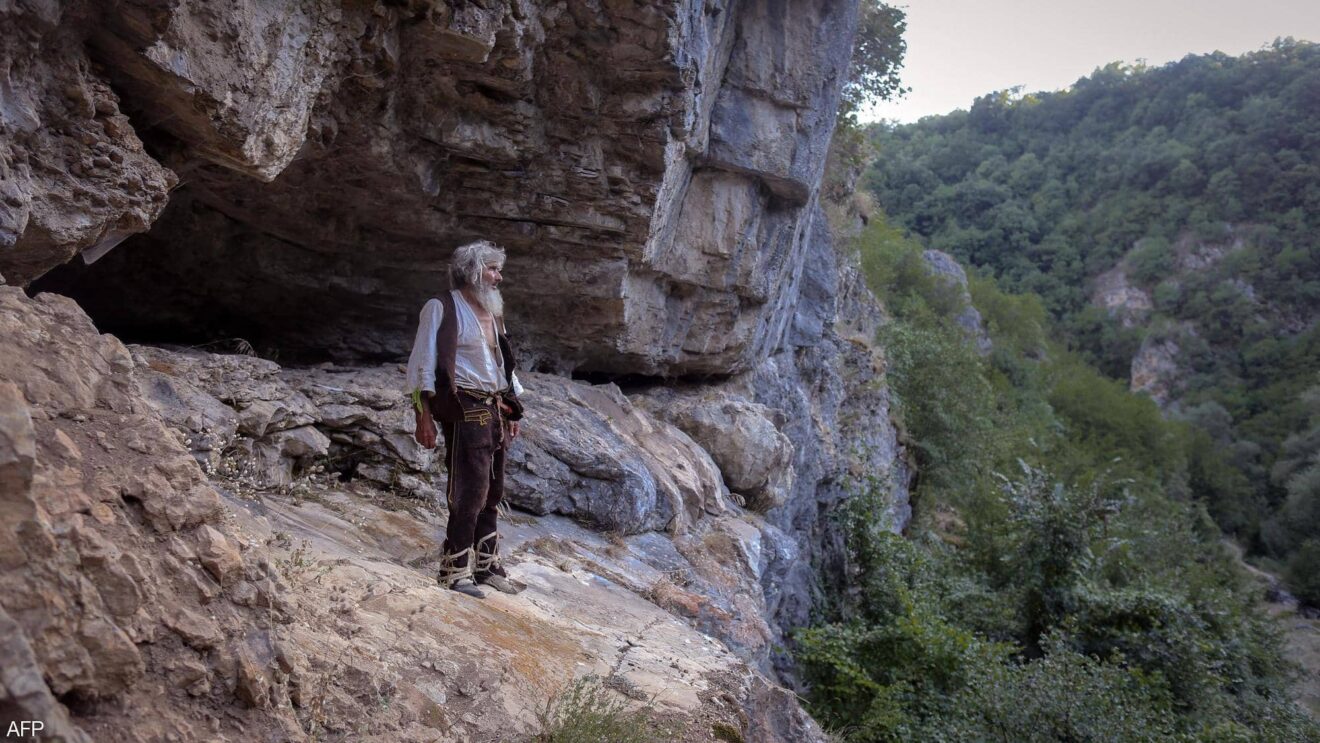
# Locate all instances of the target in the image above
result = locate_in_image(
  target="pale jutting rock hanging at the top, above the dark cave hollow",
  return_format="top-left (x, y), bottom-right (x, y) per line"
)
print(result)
top-left (92, 0), bottom-right (339, 181)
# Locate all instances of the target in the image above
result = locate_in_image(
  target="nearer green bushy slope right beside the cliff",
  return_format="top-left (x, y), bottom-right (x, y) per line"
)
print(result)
top-left (796, 215), bottom-right (1320, 743)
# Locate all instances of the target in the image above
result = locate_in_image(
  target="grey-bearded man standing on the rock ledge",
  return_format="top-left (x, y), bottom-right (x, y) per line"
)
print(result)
top-left (408, 240), bottom-right (523, 598)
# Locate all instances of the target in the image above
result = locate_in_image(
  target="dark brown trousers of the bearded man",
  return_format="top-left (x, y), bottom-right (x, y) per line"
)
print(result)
top-left (440, 389), bottom-right (508, 565)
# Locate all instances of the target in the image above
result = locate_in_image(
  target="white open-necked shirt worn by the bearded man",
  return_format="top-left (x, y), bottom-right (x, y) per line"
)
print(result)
top-left (408, 289), bottom-right (523, 395)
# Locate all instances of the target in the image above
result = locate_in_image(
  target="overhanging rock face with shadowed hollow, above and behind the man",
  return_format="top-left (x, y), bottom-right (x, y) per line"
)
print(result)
top-left (15, 0), bottom-right (855, 376)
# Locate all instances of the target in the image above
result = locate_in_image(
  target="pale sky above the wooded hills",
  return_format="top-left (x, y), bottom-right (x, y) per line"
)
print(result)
top-left (862, 0), bottom-right (1320, 121)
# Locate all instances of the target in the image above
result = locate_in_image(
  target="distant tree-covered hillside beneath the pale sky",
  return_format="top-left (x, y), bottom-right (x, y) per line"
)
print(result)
top-left (863, 40), bottom-right (1320, 603)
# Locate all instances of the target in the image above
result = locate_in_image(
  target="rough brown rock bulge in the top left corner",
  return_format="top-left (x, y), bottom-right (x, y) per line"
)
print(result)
top-left (0, 3), bottom-right (177, 285)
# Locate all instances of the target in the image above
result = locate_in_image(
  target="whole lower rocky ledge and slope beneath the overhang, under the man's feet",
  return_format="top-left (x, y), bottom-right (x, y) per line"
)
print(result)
top-left (0, 201), bottom-right (907, 740)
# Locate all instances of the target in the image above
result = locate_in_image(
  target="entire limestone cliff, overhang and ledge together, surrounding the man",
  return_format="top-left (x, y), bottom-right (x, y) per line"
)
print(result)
top-left (0, 0), bottom-right (908, 740)
